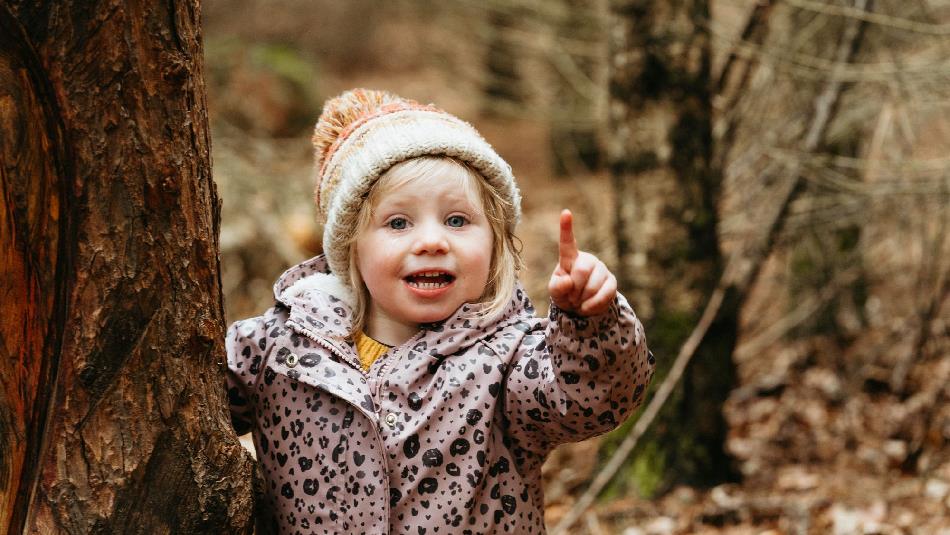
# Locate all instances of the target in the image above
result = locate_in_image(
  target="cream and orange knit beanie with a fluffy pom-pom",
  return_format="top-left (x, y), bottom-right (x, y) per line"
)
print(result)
top-left (313, 89), bottom-right (521, 285)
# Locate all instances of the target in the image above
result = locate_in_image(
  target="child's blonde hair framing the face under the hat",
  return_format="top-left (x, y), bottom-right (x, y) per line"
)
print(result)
top-left (347, 156), bottom-right (524, 334)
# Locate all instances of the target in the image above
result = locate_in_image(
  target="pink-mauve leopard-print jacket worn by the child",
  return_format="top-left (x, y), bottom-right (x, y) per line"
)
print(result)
top-left (226, 256), bottom-right (654, 535)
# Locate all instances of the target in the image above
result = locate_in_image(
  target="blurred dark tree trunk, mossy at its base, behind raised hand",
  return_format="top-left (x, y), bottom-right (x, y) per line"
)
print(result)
top-left (608, 0), bottom-right (740, 494)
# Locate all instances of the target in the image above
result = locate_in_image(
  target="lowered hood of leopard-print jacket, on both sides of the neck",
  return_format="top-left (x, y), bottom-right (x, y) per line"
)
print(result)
top-left (274, 255), bottom-right (534, 355)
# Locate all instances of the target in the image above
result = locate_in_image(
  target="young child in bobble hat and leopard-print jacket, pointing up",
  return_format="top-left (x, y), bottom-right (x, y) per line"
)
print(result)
top-left (227, 89), bottom-right (654, 534)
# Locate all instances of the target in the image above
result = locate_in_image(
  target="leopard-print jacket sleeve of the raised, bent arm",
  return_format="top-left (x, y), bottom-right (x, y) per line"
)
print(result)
top-left (504, 293), bottom-right (655, 455)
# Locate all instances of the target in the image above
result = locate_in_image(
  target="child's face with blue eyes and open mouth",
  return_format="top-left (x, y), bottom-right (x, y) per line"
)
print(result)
top-left (356, 175), bottom-right (493, 344)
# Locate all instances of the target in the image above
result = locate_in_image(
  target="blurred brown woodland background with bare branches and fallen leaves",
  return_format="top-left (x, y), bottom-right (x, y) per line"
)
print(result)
top-left (203, 0), bottom-right (950, 535)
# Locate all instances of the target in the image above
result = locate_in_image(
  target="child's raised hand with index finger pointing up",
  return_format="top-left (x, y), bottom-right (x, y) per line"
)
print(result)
top-left (548, 210), bottom-right (617, 316)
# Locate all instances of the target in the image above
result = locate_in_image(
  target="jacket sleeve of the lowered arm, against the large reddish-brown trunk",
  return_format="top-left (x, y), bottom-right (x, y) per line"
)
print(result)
top-left (224, 306), bottom-right (286, 435)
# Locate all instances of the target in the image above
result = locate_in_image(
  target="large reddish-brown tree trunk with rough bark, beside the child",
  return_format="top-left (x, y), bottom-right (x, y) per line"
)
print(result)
top-left (0, 0), bottom-right (254, 534)
